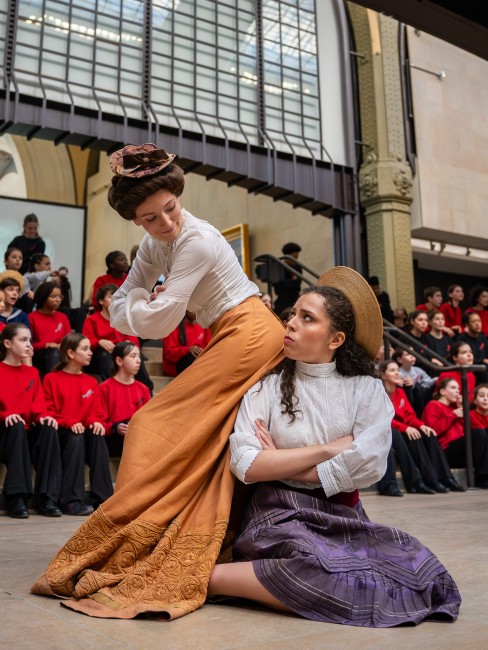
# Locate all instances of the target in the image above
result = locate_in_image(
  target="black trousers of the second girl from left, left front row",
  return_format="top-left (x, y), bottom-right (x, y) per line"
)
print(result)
top-left (58, 428), bottom-right (114, 505)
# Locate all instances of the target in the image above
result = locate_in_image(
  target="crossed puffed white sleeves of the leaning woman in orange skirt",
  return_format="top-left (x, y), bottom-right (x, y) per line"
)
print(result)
top-left (110, 232), bottom-right (216, 339)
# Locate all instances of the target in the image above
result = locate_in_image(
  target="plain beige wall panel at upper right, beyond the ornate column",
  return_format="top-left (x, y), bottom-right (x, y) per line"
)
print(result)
top-left (408, 28), bottom-right (488, 248)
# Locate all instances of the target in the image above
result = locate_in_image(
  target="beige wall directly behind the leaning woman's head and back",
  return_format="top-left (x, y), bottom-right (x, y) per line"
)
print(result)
top-left (85, 154), bottom-right (334, 295)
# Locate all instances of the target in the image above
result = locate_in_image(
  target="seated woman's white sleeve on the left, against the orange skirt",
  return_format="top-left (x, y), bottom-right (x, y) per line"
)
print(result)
top-left (229, 380), bottom-right (270, 483)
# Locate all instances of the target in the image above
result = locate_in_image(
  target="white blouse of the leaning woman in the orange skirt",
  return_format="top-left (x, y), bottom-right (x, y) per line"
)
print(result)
top-left (109, 209), bottom-right (259, 339)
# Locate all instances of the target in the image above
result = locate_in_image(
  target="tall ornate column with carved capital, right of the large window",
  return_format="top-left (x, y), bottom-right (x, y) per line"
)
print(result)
top-left (348, 3), bottom-right (415, 310)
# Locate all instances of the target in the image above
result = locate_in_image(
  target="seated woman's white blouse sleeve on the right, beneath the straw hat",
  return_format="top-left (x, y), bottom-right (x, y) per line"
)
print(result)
top-left (317, 377), bottom-right (394, 497)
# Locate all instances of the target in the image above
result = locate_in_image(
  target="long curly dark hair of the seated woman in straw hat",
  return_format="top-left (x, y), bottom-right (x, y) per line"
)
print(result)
top-left (268, 287), bottom-right (377, 424)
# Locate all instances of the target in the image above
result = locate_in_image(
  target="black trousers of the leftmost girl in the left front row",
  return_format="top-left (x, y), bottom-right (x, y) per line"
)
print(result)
top-left (0, 422), bottom-right (61, 505)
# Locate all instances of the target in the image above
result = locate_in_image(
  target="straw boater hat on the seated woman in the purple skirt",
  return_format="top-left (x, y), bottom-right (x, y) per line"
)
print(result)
top-left (317, 266), bottom-right (383, 360)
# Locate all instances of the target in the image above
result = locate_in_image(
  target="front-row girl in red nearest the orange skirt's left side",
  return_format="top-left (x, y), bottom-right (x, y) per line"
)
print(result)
top-left (100, 341), bottom-right (151, 456)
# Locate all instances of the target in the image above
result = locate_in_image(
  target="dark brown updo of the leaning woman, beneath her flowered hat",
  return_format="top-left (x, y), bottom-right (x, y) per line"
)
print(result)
top-left (108, 162), bottom-right (185, 221)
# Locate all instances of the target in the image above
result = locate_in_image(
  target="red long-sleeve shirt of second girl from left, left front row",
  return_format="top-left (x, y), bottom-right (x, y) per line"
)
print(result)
top-left (43, 370), bottom-right (103, 429)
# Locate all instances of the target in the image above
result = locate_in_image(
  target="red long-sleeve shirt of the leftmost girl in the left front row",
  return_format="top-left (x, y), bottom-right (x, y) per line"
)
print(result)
top-left (0, 361), bottom-right (49, 427)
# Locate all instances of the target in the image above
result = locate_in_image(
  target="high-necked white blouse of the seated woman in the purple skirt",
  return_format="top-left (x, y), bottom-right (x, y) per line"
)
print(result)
top-left (230, 361), bottom-right (394, 496)
